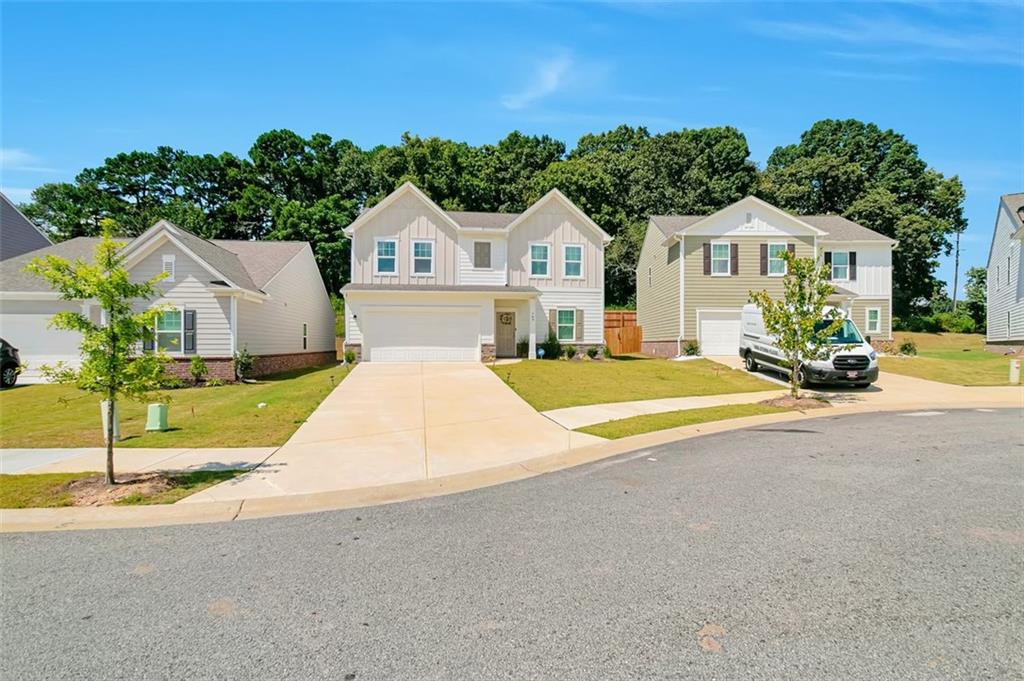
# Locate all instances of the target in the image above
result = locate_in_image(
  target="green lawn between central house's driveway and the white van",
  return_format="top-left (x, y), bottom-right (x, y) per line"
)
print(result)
top-left (494, 357), bottom-right (773, 412)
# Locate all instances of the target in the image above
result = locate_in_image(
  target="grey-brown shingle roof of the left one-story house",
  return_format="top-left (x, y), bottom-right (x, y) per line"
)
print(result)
top-left (0, 220), bottom-right (307, 295)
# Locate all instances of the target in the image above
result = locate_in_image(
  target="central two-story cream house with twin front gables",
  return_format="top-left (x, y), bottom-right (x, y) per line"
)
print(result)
top-left (342, 182), bottom-right (611, 361)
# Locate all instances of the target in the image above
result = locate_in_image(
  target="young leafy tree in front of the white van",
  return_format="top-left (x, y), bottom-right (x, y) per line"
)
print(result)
top-left (751, 253), bottom-right (844, 398)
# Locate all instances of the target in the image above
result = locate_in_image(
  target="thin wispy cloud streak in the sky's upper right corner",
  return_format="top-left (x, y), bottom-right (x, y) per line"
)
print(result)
top-left (751, 15), bottom-right (1024, 67)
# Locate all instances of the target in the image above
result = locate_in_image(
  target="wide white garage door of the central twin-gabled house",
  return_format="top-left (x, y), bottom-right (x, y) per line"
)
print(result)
top-left (360, 307), bottom-right (480, 361)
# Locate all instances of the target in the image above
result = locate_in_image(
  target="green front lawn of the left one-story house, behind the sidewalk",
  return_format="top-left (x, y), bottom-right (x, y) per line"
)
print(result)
top-left (0, 366), bottom-right (348, 448)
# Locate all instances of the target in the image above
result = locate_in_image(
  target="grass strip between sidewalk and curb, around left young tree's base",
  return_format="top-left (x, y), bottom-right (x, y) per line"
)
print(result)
top-left (0, 470), bottom-right (245, 508)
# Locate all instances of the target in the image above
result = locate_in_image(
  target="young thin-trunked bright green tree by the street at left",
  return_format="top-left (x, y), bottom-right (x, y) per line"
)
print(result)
top-left (28, 220), bottom-right (168, 484)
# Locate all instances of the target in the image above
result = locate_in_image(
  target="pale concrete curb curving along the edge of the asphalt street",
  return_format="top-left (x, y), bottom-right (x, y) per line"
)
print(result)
top-left (0, 400), bottom-right (1022, 534)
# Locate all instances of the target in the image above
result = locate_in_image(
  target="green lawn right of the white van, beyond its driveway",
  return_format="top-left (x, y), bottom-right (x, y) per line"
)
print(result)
top-left (879, 332), bottom-right (1010, 385)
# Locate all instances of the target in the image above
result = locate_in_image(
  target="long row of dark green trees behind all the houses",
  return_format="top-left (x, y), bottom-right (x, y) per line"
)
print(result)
top-left (23, 120), bottom-right (966, 315)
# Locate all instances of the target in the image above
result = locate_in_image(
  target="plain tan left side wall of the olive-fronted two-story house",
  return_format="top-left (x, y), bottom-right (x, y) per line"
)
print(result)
top-left (636, 223), bottom-right (680, 341)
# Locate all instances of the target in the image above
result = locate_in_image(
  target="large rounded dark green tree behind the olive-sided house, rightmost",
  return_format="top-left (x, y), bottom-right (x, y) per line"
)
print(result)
top-left (759, 120), bottom-right (966, 315)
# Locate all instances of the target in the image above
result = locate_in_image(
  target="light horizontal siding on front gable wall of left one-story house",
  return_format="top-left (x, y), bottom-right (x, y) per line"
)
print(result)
top-left (131, 241), bottom-right (231, 357)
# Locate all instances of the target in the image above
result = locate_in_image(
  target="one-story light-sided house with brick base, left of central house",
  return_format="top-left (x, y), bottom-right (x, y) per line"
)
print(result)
top-left (0, 220), bottom-right (336, 380)
